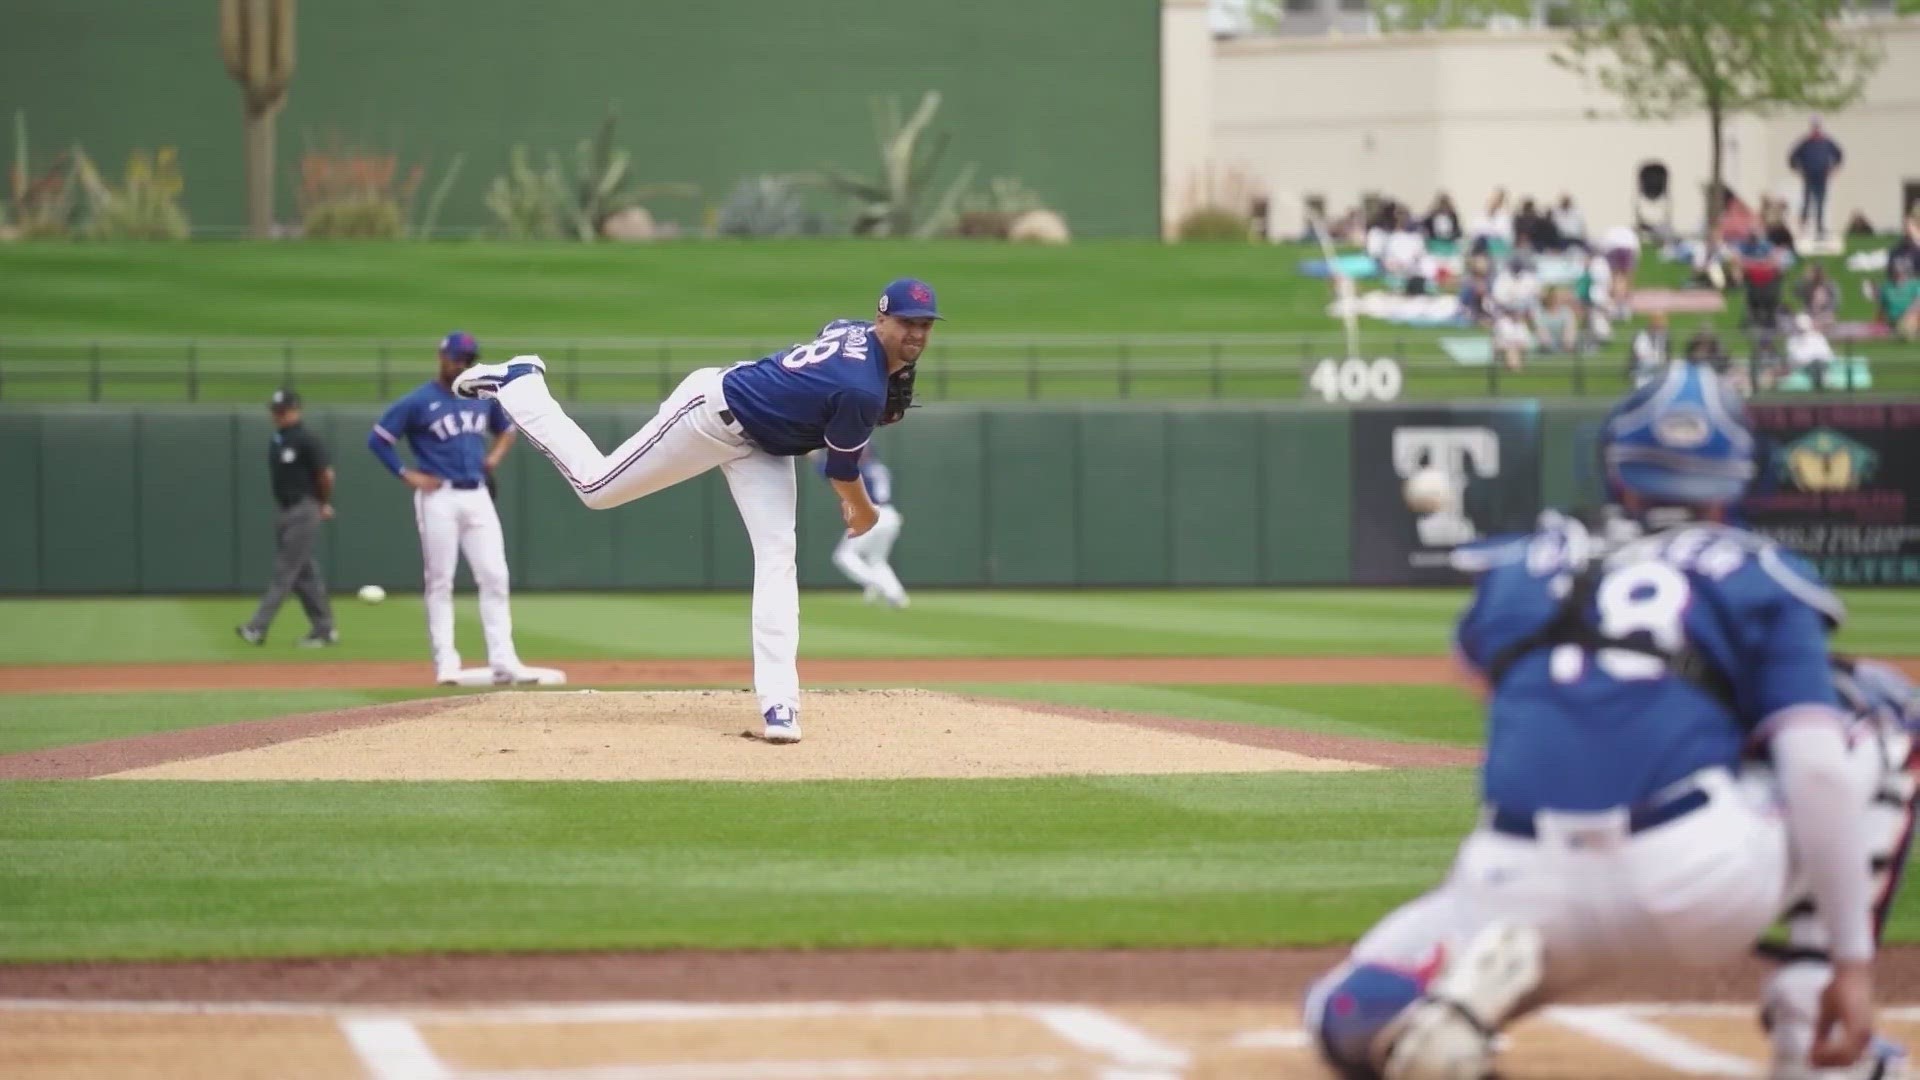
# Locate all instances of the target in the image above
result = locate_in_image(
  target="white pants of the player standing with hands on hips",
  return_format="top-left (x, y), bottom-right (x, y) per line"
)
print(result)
top-left (413, 486), bottom-right (520, 675)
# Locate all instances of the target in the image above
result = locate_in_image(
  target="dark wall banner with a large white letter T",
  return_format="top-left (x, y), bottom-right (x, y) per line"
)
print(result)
top-left (1350, 402), bottom-right (1540, 584)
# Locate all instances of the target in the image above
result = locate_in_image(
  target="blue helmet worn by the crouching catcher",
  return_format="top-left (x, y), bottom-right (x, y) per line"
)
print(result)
top-left (1599, 363), bottom-right (1753, 505)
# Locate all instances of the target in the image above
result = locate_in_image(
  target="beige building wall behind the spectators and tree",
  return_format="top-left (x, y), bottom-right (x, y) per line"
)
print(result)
top-left (1162, 0), bottom-right (1920, 234)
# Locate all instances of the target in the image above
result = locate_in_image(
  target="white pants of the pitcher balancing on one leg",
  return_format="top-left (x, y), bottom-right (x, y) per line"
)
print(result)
top-left (497, 367), bottom-right (801, 713)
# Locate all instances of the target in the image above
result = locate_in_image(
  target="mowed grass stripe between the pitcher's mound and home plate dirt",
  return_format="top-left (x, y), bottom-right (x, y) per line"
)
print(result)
top-left (0, 771), bottom-right (1473, 961)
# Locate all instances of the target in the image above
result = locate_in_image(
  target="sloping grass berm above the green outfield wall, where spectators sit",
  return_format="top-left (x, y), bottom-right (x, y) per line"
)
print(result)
top-left (0, 240), bottom-right (1920, 402)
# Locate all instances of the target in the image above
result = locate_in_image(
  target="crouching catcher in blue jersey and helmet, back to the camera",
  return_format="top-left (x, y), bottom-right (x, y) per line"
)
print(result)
top-left (1306, 363), bottom-right (1874, 1080)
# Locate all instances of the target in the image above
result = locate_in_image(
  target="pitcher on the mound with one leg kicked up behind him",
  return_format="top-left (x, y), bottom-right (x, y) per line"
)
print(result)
top-left (453, 279), bottom-right (941, 742)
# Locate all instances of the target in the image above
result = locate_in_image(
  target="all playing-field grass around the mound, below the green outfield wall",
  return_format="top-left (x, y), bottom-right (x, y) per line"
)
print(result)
top-left (0, 590), bottom-right (1920, 961)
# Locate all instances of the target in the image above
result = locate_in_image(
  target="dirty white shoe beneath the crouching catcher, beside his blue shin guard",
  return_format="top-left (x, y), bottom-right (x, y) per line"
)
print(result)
top-left (1380, 924), bottom-right (1546, 1080)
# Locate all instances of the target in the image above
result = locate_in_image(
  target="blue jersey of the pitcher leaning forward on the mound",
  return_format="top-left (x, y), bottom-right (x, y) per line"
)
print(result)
top-left (722, 319), bottom-right (887, 455)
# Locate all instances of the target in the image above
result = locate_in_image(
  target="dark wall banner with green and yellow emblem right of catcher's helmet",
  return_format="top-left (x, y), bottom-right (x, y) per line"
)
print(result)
top-left (1741, 404), bottom-right (1920, 586)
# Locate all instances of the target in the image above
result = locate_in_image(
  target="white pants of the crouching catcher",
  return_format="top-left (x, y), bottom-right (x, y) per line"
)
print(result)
top-left (1329, 769), bottom-right (1788, 1001)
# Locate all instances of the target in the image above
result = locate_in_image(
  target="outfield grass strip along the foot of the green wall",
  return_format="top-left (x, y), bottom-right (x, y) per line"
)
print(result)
top-left (0, 588), bottom-right (1920, 671)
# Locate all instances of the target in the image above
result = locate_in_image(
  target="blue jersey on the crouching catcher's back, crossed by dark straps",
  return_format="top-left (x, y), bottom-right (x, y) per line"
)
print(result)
top-left (1455, 523), bottom-right (1845, 811)
